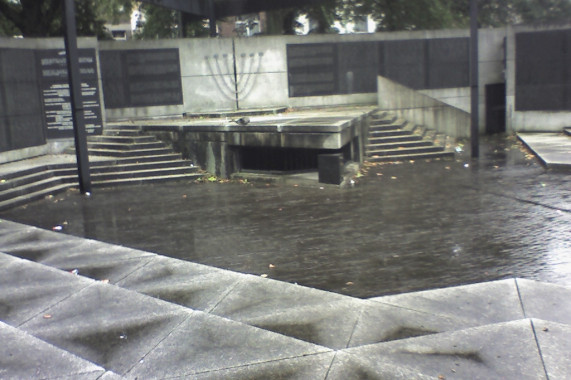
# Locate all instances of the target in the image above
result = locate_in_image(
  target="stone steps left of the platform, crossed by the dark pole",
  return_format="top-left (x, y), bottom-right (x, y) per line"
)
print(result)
top-left (0, 126), bottom-right (201, 211)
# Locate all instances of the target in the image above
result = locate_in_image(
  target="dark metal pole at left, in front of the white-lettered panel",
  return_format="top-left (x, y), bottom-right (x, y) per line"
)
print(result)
top-left (64, 0), bottom-right (91, 194)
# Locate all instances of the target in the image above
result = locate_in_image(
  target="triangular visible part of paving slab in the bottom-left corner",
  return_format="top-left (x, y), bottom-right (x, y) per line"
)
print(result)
top-left (0, 322), bottom-right (105, 380)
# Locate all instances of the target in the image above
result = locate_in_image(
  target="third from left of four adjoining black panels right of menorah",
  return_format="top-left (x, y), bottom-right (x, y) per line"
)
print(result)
top-left (384, 40), bottom-right (426, 89)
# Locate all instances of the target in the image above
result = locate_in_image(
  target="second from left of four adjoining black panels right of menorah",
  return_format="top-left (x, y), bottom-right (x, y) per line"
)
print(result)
top-left (337, 42), bottom-right (379, 94)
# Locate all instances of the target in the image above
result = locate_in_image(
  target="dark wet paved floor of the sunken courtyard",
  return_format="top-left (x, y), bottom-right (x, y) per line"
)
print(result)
top-left (0, 137), bottom-right (571, 298)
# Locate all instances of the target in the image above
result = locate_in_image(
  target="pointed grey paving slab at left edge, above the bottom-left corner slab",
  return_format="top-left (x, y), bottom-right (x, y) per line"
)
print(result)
top-left (0, 253), bottom-right (93, 326)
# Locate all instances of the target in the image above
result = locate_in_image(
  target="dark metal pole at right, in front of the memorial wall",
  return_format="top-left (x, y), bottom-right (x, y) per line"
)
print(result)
top-left (470, 0), bottom-right (480, 158)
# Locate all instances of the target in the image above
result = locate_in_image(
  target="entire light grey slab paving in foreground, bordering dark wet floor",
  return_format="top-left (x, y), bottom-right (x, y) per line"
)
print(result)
top-left (0, 221), bottom-right (571, 379)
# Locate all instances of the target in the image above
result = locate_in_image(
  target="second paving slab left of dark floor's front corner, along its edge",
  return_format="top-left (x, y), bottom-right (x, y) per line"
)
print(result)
top-left (117, 256), bottom-right (245, 311)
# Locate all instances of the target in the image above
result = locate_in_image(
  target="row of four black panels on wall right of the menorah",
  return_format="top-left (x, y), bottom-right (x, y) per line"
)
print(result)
top-left (286, 37), bottom-right (470, 97)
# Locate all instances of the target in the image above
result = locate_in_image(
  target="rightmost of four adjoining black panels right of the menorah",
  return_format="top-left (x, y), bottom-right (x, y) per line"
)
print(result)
top-left (427, 38), bottom-right (470, 89)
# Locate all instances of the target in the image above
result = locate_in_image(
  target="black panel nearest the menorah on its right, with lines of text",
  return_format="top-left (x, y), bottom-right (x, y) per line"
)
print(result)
top-left (287, 43), bottom-right (339, 97)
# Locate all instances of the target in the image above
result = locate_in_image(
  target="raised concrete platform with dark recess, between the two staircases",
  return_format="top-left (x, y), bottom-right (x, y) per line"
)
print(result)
top-left (113, 106), bottom-right (376, 177)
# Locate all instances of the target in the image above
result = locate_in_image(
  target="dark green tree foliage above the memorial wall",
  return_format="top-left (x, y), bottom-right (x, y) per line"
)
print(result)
top-left (0, 0), bottom-right (571, 38)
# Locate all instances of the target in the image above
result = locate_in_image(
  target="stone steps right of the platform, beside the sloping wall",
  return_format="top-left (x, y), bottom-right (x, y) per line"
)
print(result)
top-left (366, 112), bottom-right (454, 162)
